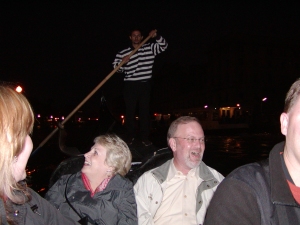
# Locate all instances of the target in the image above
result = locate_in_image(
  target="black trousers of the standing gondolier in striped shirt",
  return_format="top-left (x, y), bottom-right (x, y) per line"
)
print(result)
top-left (124, 80), bottom-right (151, 140)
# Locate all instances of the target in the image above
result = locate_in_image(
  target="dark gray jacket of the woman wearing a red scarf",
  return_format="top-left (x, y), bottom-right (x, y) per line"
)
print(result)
top-left (45, 172), bottom-right (137, 225)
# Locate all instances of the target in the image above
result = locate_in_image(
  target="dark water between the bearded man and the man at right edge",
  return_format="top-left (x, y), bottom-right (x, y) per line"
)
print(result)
top-left (203, 133), bottom-right (284, 175)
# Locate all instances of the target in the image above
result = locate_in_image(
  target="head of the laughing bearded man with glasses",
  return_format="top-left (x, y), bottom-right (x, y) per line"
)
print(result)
top-left (167, 116), bottom-right (205, 174)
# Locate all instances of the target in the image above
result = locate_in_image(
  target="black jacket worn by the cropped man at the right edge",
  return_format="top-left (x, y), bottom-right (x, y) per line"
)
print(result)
top-left (204, 142), bottom-right (300, 225)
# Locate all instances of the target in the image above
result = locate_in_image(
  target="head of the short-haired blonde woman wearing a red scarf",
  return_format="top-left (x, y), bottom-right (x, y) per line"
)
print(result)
top-left (81, 134), bottom-right (132, 179)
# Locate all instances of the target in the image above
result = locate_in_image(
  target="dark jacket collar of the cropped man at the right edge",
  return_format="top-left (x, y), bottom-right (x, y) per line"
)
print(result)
top-left (269, 141), bottom-right (299, 206)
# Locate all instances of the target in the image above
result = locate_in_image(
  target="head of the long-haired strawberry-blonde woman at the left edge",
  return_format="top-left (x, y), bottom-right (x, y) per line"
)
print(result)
top-left (0, 84), bottom-right (34, 202)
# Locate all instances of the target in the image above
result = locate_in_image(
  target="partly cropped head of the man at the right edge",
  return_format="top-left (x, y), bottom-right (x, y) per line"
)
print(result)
top-left (280, 79), bottom-right (300, 154)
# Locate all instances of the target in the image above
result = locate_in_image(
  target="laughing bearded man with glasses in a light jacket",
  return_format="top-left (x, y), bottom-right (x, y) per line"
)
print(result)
top-left (134, 116), bottom-right (224, 225)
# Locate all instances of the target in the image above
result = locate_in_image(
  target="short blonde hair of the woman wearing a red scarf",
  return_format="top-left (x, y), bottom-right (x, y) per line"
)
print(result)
top-left (94, 134), bottom-right (132, 176)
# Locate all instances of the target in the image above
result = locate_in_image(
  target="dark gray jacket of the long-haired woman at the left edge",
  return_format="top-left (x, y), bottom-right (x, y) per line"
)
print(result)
top-left (0, 189), bottom-right (78, 225)
